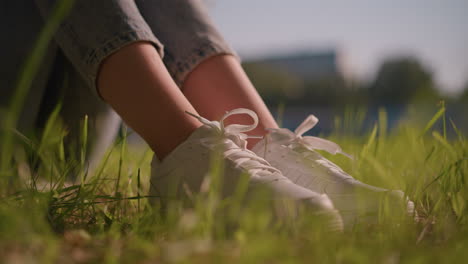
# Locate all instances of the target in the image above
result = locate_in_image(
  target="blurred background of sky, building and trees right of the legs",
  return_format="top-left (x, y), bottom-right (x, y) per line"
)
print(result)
top-left (205, 0), bottom-right (468, 134)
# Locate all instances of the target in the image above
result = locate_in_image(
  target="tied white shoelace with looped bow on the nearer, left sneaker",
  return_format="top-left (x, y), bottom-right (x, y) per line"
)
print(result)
top-left (185, 108), bottom-right (279, 175)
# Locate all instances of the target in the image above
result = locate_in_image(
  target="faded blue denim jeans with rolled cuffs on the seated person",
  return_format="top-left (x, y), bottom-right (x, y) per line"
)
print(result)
top-left (0, 0), bottom-right (235, 163)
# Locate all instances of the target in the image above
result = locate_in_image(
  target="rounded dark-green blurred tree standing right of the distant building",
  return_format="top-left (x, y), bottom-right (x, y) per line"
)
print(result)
top-left (369, 57), bottom-right (438, 105)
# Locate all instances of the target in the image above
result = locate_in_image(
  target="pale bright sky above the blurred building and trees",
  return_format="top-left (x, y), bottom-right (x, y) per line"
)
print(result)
top-left (206, 0), bottom-right (468, 93)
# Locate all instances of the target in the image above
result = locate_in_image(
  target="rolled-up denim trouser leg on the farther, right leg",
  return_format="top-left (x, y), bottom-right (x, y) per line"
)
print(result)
top-left (135, 0), bottom-right (239, 88)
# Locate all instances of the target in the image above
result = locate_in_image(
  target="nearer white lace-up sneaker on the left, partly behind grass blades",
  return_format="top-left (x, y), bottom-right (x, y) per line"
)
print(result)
top-left (150, 109), bottom-right (343, 230)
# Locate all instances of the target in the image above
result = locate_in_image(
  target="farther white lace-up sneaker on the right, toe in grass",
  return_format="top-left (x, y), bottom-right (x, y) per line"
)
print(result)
top-left (253, 115), bottom-right (414, 227)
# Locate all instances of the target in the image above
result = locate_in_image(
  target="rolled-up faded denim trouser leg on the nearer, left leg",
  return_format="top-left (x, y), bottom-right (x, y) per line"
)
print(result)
top-left (35, 0), bottom-right (163, 98)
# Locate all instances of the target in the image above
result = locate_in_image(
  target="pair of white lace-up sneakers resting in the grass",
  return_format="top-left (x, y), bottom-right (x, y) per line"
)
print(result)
top-left (150, 108), bottom-right (414, 231)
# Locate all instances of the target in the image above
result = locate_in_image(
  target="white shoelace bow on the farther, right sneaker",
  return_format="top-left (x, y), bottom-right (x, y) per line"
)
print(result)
top-left (269, 115), bottom-right (353, 159)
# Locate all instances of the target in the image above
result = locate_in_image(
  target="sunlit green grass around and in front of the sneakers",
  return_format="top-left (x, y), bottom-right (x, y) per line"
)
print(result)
top-left (0, 102), bottom-right (468, 263)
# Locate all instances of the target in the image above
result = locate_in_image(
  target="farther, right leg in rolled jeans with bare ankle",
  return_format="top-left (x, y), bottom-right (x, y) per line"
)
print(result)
top-left (135, 0), bottom-right (277, 146)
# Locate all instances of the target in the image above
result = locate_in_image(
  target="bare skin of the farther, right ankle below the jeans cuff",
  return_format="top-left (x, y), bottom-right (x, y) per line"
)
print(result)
top-left (182, 55), bottom-right (278, 148)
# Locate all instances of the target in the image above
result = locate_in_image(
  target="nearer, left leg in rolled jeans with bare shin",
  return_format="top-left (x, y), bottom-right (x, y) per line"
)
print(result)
top-left (35, 0), bottom-right (187, 158)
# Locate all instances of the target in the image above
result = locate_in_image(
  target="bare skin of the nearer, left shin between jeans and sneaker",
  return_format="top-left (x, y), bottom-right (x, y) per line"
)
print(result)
top-left (97, 42), bottom-right (202, 160)
